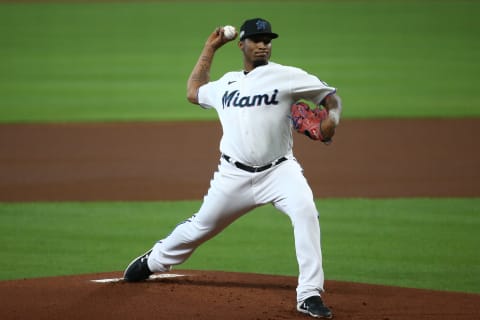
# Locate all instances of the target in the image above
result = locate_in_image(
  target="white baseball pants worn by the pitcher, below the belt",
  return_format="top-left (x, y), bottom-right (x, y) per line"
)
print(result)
top-left (148, 156), bottom-right (324, 302)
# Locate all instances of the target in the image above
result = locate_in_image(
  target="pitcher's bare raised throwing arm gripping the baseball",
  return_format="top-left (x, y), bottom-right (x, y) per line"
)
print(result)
top-left (187, 28), bottom-right (235, 104)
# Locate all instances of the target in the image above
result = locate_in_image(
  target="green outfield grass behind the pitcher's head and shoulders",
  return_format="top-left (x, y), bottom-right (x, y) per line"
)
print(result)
top-left (0, 0), bottom-right (480, 122)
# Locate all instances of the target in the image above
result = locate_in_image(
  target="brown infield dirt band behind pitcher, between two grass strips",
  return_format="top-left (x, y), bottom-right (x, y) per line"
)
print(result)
top-left (0, 119), bottom-right (480, 201)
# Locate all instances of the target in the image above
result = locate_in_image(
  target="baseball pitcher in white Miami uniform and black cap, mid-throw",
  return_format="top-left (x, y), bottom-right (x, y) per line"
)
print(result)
top-left (124, 18), bottom-right (341, 318)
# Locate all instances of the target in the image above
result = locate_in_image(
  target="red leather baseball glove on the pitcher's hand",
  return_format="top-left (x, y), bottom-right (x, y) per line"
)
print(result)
top-left (290, 100), bottom-right (331, 143)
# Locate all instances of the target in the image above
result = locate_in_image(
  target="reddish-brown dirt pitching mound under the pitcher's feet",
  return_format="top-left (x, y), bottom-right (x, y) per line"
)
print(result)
top-left (0, 270), bottom-right (480, 320)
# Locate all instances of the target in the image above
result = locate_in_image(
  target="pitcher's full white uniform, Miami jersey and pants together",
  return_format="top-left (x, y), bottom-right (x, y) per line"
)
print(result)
top-left (148, 62), bottom-right (335, 302)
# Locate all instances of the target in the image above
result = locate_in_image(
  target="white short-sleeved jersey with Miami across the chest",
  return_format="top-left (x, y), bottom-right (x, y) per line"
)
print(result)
top-left (198, 62), bottom-right (336, 166)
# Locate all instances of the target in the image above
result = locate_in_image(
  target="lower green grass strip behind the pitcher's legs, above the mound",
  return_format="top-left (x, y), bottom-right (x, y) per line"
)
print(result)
top-left (0, 198), bottom-right (480, 293)
